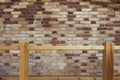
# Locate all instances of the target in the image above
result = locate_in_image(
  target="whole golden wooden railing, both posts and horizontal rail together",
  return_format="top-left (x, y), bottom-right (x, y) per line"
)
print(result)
top-left (0, 42), bottom-right (120, 80)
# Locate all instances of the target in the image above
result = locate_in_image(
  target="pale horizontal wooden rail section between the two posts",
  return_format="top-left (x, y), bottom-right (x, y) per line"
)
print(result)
top-left (28, 46), bottom-right (104, 50)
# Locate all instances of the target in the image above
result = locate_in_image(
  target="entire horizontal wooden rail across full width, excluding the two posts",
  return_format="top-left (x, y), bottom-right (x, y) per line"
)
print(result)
top-left (0, 45), bottom-right (120, 50)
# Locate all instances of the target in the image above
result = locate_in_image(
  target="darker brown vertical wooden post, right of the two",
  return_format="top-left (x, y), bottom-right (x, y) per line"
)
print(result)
top-left (103, 42), bottom-right (114, 80)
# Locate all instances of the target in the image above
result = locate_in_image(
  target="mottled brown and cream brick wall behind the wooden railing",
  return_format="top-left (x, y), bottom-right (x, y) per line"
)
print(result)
top-left (0, 0), bottom-right (120, 75)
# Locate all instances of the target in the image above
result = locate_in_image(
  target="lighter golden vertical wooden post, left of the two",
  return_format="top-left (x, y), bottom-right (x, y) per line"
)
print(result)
top-left (20, 42), bottom-right (28, 80)
